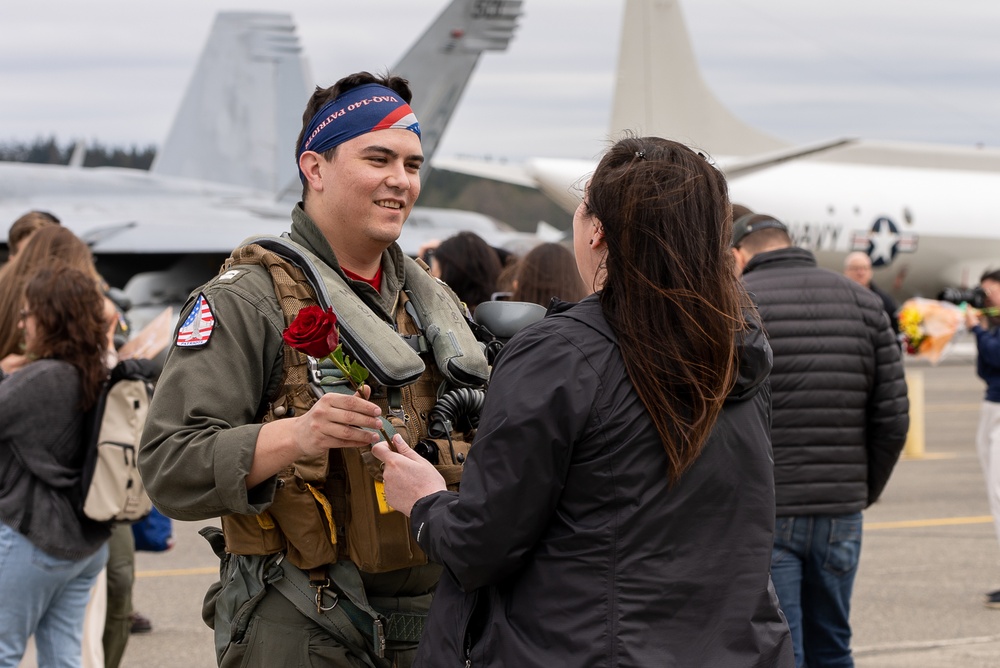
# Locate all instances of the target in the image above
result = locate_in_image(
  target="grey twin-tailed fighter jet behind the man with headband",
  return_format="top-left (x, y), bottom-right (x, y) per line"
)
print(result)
top-left (0, 0), bottom-right (531, 316)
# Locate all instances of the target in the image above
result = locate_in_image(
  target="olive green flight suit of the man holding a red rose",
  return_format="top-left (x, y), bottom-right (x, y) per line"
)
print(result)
top-left (139, 204), bottom-right (440, 667)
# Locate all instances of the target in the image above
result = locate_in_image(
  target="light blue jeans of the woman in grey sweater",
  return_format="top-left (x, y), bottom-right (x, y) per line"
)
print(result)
top-left (0, 523), bottom-right (108, 668)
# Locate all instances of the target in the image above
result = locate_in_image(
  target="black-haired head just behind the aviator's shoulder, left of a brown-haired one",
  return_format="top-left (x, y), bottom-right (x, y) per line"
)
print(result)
top-left (431, 232), bottom-right (502, 312)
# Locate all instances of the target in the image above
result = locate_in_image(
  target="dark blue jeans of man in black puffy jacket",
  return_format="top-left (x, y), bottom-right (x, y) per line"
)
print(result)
top-left (771, 512), bottom-right (861, 668)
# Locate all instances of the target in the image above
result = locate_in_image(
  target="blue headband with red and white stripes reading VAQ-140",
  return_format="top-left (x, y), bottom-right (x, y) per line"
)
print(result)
top-left (299, 84), bottom-right (420, 183)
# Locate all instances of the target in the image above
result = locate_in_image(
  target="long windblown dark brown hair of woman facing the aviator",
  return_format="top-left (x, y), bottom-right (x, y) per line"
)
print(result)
top-left (585, 137), bottom-right (749, 482)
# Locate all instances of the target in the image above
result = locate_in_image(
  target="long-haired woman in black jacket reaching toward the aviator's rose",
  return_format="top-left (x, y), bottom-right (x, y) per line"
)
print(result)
top-left (374, 137), bottom-right (792, 668)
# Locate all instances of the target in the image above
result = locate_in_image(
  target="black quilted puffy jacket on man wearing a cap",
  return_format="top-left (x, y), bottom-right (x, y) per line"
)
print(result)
top-left (743, 248), bottom-right (910, 516)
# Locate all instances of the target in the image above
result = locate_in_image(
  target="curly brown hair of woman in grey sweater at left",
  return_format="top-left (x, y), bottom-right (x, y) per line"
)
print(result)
top-left (24, 263), bottom-right (108, 410)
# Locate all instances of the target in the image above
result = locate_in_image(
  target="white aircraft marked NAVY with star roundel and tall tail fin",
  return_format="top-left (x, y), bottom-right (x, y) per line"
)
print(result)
top-left (436, 0), bottom-right (1000, 298)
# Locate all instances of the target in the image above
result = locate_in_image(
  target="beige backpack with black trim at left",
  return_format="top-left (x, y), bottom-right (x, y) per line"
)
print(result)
top-left (80, 359), bottom-right (156, 523)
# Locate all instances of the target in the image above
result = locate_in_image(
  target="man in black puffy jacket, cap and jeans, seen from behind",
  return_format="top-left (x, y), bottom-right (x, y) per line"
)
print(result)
top-left (733, 214), bottom-right (909, 668)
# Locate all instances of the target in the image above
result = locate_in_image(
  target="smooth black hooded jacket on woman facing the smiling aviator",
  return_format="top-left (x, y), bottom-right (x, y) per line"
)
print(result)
top-left (411, 296), bottom-right (793, 668)
